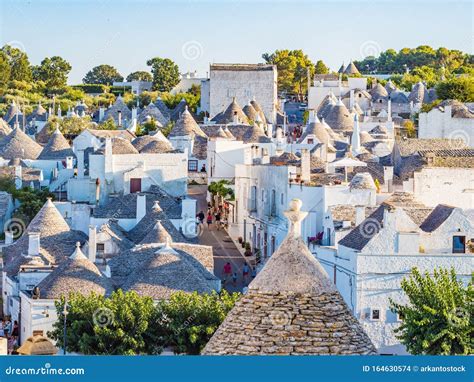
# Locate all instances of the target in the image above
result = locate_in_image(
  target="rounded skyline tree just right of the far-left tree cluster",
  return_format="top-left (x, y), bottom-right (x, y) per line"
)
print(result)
top-left (33, 56), bottom-right (72, 89)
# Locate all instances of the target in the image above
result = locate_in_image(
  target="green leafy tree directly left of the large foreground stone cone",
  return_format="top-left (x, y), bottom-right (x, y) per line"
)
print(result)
top-left (154, 290), bottom-right (240, 354)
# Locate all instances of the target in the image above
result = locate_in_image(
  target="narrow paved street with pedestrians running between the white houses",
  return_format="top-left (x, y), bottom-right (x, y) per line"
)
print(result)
top-left (188, 185), bottom-right (250, 292)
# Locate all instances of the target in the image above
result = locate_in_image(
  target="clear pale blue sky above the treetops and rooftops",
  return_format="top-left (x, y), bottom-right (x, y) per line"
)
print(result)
top-left (0, 0), bottom-right (474, 83)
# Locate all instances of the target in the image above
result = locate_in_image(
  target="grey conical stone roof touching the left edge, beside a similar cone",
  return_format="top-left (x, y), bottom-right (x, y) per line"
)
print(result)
top-left (0, 128), bottom-right (43, 159)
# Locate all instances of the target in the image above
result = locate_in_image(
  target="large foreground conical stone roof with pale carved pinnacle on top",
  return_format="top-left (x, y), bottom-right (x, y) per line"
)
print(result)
top-left (202, 199), bottom-right (375, 355)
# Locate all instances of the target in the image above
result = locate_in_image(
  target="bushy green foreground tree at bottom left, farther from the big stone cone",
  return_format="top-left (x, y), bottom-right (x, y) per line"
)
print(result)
top-left (48, 290), bottom-right (156, 355)
